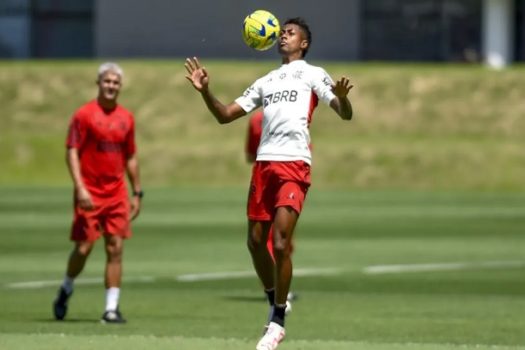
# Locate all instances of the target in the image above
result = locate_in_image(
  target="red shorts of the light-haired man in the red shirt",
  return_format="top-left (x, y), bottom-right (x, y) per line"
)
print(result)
top-left (71, 195), bottom-right (131, 241)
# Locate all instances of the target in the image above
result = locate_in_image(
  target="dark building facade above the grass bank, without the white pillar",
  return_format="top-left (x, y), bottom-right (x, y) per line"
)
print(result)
top-left (0, 0), bottom-right (525, 62)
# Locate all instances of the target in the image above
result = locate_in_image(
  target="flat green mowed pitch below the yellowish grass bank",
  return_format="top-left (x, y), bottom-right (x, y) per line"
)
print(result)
top-left (0, 187), bottom-right (525, 350)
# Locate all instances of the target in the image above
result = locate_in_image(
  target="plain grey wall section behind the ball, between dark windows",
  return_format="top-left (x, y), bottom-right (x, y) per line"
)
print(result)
top-left (95, 0), bottom-right (360, 60)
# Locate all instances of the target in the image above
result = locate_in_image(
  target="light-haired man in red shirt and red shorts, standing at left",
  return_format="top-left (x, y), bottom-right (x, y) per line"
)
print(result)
top-left (53, 62), bottom-right (143, 323)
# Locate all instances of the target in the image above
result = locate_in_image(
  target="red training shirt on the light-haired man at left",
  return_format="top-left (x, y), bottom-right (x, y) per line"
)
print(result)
top-left (66, 100), bottom-right (136, 198)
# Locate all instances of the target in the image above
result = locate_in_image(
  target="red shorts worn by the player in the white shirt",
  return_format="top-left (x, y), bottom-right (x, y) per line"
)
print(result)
top-left (248, 161), bottom-right (310, 221)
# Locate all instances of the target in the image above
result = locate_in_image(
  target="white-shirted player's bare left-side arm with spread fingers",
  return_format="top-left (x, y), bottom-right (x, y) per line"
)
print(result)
top-left (184, 57), bottom-right (246, 124)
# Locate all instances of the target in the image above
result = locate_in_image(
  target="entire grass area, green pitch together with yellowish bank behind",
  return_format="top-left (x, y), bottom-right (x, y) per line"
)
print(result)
top-left (0, 60), bottom-right (525, 350)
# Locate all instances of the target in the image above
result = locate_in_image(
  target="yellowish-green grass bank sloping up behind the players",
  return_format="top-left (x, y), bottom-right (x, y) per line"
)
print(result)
top-left (0, 58), bottom-right (525, 192)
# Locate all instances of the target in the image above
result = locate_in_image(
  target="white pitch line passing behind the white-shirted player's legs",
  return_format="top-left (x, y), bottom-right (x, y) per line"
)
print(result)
top-left (175, 268), bottom-right (341, 282)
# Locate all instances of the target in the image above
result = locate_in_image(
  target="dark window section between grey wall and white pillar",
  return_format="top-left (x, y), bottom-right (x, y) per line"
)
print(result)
top-left (361, 0), bottom-right (482, 61)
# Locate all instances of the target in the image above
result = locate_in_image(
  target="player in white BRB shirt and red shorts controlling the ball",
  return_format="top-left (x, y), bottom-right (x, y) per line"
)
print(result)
top-left (185, 18), bottom-right (353, 350)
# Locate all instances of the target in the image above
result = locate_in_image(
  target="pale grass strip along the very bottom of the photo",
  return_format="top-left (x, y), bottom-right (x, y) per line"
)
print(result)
top-left (0, 334), bottom-right (525, 350)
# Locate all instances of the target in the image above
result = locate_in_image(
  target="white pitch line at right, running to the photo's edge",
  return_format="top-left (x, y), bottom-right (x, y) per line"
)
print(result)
top-left (363, 260), bottom-right (525, 275)
